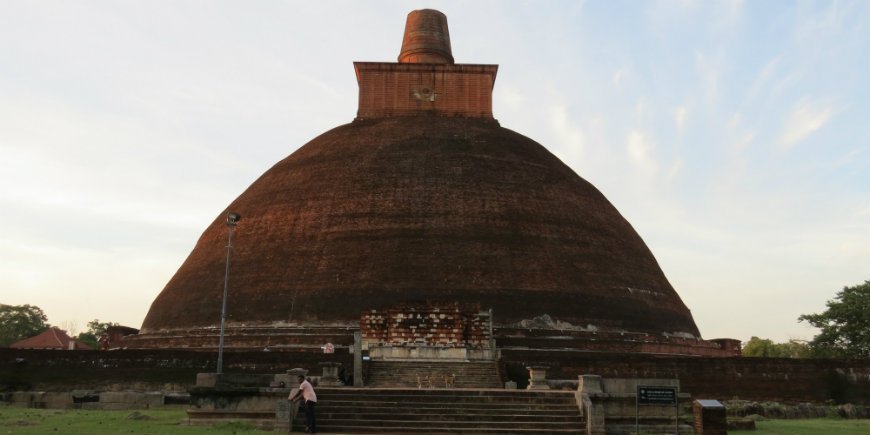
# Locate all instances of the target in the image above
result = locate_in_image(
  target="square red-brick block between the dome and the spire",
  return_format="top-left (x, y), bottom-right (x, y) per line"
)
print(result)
top-left (354, 62), bottom-right (498, 119)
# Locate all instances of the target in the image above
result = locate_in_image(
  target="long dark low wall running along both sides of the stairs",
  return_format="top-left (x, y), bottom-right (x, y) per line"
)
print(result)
top-left (0, 349), bottom-right (870, 405)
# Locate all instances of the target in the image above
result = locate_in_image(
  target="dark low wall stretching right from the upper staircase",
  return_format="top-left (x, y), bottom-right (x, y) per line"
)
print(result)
top-left (501, 349), bottom-right (870, 404)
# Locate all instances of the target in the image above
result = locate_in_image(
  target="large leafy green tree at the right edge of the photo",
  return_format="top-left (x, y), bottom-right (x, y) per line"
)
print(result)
top-left (798, 281), bottom-right (870, 358)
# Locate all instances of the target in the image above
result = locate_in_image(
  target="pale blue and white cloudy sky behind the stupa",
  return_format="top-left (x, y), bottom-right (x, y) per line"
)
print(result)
top-left (0, 0), bottom-right (870, 341)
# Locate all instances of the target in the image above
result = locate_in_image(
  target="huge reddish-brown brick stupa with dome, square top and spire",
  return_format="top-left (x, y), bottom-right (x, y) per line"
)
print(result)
top-left (127, 10), bottom-right (719, 354)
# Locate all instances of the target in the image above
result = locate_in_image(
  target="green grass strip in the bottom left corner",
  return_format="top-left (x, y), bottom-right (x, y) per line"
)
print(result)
top-left (0, 406), bottom-right (274, 435)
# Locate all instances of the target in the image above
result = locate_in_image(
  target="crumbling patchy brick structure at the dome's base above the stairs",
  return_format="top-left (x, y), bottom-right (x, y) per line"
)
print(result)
top-left (360, 302), bottom-right (491, 348)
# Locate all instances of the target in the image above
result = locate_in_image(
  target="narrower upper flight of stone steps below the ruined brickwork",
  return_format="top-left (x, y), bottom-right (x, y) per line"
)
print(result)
top-left (365, 360), bottom-right (504, 389)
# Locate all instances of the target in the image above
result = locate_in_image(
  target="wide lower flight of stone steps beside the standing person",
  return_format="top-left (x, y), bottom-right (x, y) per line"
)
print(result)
top-left (293, 387), bottom-right (586, 434)
